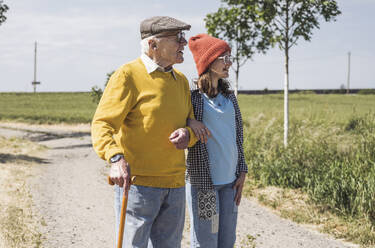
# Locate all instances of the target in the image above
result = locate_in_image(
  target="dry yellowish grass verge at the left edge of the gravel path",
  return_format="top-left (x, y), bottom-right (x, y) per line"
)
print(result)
top-left (0, 136), bottom-right (45, 248)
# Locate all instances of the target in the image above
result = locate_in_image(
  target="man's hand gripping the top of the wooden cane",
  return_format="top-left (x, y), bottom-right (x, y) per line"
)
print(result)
top-left (109, 158), bottom-right (131, 190)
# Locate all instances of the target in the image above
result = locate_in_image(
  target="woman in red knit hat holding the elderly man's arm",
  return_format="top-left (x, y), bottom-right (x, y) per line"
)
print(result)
top-left (186, 34), bottom-right (247, 248)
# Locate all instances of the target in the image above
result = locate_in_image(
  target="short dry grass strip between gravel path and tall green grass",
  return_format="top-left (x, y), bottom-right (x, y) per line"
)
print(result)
top-left (244, 183), bottom-right (375, 248)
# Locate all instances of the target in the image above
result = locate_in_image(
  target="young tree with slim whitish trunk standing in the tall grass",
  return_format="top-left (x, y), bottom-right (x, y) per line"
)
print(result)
top-left (260, 0), bottom-right (341, 146)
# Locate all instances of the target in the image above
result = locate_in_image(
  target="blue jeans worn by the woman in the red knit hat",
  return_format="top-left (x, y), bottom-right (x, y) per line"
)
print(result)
top-left (186, 183), bottom-right (238, 248)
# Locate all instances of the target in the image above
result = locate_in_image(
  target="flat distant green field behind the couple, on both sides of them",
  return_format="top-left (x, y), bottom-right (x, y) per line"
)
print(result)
top-left (0, 92), bottom-right (375, 124)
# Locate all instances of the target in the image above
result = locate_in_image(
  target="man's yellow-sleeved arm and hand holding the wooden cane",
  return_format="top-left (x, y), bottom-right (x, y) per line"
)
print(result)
top-left (91, 69), bottom-right (133, 189)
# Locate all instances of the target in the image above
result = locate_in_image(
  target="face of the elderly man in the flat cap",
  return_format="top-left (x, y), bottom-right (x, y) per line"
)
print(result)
top-left (155, 31), bottom-right (187, 68)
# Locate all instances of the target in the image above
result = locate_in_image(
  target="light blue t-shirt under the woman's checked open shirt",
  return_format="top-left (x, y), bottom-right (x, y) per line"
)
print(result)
top-left (202, 93), bottom-right (238, 185)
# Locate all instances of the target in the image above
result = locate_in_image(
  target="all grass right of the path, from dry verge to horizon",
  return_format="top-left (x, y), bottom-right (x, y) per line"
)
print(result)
top-left (240, 95), bottom-right (375, 247)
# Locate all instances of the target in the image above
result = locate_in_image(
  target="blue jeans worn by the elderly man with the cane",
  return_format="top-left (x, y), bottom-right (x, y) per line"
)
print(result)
top-left (115, 185), bottom-right (185, 248)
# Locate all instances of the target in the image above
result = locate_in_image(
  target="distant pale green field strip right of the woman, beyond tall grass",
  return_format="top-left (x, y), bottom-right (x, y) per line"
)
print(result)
top-left (239, 94), bottom-right (375, 123)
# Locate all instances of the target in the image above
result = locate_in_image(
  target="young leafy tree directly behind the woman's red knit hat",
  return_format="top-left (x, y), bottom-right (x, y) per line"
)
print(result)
top-left (205, 0), bottom-right (271, 96)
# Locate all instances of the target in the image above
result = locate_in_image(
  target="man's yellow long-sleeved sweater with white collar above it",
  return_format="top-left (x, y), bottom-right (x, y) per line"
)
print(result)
top-left (91, 58), bottom-right (197, 188)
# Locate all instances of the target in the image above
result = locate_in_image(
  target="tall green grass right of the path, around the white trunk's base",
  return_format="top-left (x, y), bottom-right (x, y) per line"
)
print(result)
top-left (245, 105), bottom-right (375, 226)
